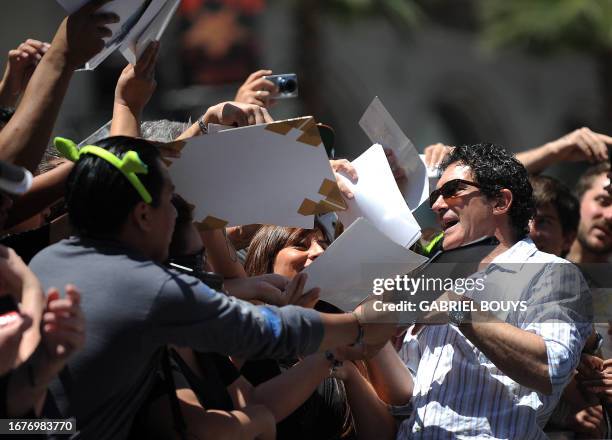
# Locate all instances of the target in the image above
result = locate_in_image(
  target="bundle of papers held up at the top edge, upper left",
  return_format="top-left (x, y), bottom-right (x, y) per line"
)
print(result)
top-left (57, 0), bottom-right (180, 70)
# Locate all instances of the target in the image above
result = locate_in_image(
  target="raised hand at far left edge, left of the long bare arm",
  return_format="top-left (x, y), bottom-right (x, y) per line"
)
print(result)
top-left (0, 39), bottom-right (50, 107)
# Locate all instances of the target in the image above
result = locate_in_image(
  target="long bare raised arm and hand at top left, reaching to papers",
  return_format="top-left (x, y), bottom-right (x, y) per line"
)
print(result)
top-left (0, 0), bottom-right (118, 171)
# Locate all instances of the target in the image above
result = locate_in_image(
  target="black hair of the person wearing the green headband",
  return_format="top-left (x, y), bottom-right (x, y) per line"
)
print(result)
top-left (66, 136), bottom-right (164, 237)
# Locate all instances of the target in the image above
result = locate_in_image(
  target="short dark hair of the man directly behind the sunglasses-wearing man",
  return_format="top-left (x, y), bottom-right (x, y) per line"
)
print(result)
top-left (529, 176), bottom-right (580, 236)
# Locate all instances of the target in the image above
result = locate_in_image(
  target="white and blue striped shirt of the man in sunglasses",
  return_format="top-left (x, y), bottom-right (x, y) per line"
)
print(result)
top-left (397, 239), bottom-right (591, 439)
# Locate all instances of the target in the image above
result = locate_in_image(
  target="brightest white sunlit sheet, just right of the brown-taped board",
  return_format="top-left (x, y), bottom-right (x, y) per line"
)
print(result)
top-left (338, 144), bottom-right (421, 248)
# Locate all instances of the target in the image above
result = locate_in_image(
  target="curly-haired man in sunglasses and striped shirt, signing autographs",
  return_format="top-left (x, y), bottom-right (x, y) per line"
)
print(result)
top-left (398, 144), bottom-right (590, 439)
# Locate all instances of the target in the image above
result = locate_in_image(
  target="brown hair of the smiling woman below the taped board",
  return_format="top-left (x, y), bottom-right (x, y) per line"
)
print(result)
top-left (244, 223), bottom-right (326, 277)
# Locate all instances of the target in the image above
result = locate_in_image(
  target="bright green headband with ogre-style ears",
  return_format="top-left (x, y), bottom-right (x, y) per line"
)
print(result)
top-left (53, 137), bottom-right (153, 204)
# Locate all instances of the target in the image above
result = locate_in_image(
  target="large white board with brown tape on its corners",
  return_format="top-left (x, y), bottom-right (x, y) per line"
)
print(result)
top-left (164, 117), bottom-right (346, 229)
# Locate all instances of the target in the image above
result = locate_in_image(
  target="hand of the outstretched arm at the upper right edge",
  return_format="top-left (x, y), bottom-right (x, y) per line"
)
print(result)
top-left (545, 127), bottom-right (612, 163)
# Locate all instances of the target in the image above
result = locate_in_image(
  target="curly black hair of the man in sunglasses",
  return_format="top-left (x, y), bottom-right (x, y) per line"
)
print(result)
top-left (441, 143), bottom-right (535, 240)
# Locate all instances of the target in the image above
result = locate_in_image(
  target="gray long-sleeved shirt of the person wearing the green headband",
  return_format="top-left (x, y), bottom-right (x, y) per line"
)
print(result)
top-left (30, 237), bottom-right (323, 439)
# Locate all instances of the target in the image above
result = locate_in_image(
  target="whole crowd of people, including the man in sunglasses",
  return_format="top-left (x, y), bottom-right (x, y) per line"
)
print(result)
top-left (0, 1), bottom-right (612, 439)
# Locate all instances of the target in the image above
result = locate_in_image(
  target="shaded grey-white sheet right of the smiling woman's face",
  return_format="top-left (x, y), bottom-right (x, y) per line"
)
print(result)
top-left (304, 217), bottom-right (427, 311)
